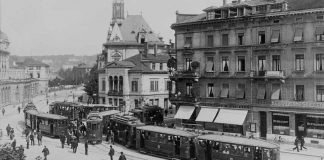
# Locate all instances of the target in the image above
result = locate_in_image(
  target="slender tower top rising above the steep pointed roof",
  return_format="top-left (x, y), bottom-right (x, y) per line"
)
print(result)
top-left (110, 0), bottom-right (125, 27)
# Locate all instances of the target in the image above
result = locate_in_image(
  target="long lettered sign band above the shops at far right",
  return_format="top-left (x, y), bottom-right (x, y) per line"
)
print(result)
top-left (271, 101), bottom-right (324, 108)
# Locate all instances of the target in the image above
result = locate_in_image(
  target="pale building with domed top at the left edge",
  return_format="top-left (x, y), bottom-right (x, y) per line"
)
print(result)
top-left (0, 31), bottom-right (38, 107)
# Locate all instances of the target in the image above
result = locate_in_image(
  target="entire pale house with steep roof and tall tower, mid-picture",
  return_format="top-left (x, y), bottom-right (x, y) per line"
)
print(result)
top-left (97, 0), bottom-right (168, 111)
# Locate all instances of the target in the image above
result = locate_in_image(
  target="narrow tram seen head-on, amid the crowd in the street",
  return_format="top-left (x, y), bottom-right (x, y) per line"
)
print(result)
top-left (86, 112), bottom-right (103, 144)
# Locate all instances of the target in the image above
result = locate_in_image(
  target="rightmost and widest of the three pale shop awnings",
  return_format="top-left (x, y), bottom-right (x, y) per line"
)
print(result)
top-left (214, 109), bottom-right (248, 125)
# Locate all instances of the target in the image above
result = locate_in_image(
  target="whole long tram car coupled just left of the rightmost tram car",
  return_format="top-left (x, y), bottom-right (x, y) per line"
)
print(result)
top-left (136, 126), bottom-right (196, 160)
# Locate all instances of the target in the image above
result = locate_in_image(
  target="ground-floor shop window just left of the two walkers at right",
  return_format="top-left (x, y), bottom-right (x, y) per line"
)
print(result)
top-left (272, 113), bottom-right (290, 135)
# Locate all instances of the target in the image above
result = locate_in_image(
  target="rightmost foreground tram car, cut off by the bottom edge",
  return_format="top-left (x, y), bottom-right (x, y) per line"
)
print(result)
top-left (197, 135), bottom-right (280, 160)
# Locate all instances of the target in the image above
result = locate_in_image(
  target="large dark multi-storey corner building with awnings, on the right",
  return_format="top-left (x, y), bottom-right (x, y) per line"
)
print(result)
top-left (170, 0), bottom-right (324, 144)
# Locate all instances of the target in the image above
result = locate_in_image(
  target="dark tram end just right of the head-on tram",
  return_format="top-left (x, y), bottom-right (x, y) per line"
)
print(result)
top-left (110, 115), bottom-right (145, 148)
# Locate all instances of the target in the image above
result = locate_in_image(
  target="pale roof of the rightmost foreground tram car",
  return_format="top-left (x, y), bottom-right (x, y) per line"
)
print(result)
top-left (198, 134), bottom-right (279, 149)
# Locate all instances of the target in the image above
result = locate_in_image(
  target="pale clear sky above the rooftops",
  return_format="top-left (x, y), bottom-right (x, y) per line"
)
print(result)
top-left (0, 0), bottom-right (222, 56)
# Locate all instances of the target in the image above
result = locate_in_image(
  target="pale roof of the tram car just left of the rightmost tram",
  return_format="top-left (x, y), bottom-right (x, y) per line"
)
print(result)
top-left (138, 126), bottom-right (197, 137)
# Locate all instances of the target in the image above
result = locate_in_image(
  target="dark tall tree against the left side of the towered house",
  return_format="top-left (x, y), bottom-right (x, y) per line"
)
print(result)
top-left (84, 65), bottom-right (99, 103)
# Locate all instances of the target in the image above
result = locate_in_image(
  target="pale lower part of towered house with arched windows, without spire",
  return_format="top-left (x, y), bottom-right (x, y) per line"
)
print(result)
top-left (98, 48), bottom-right (170, 112)
